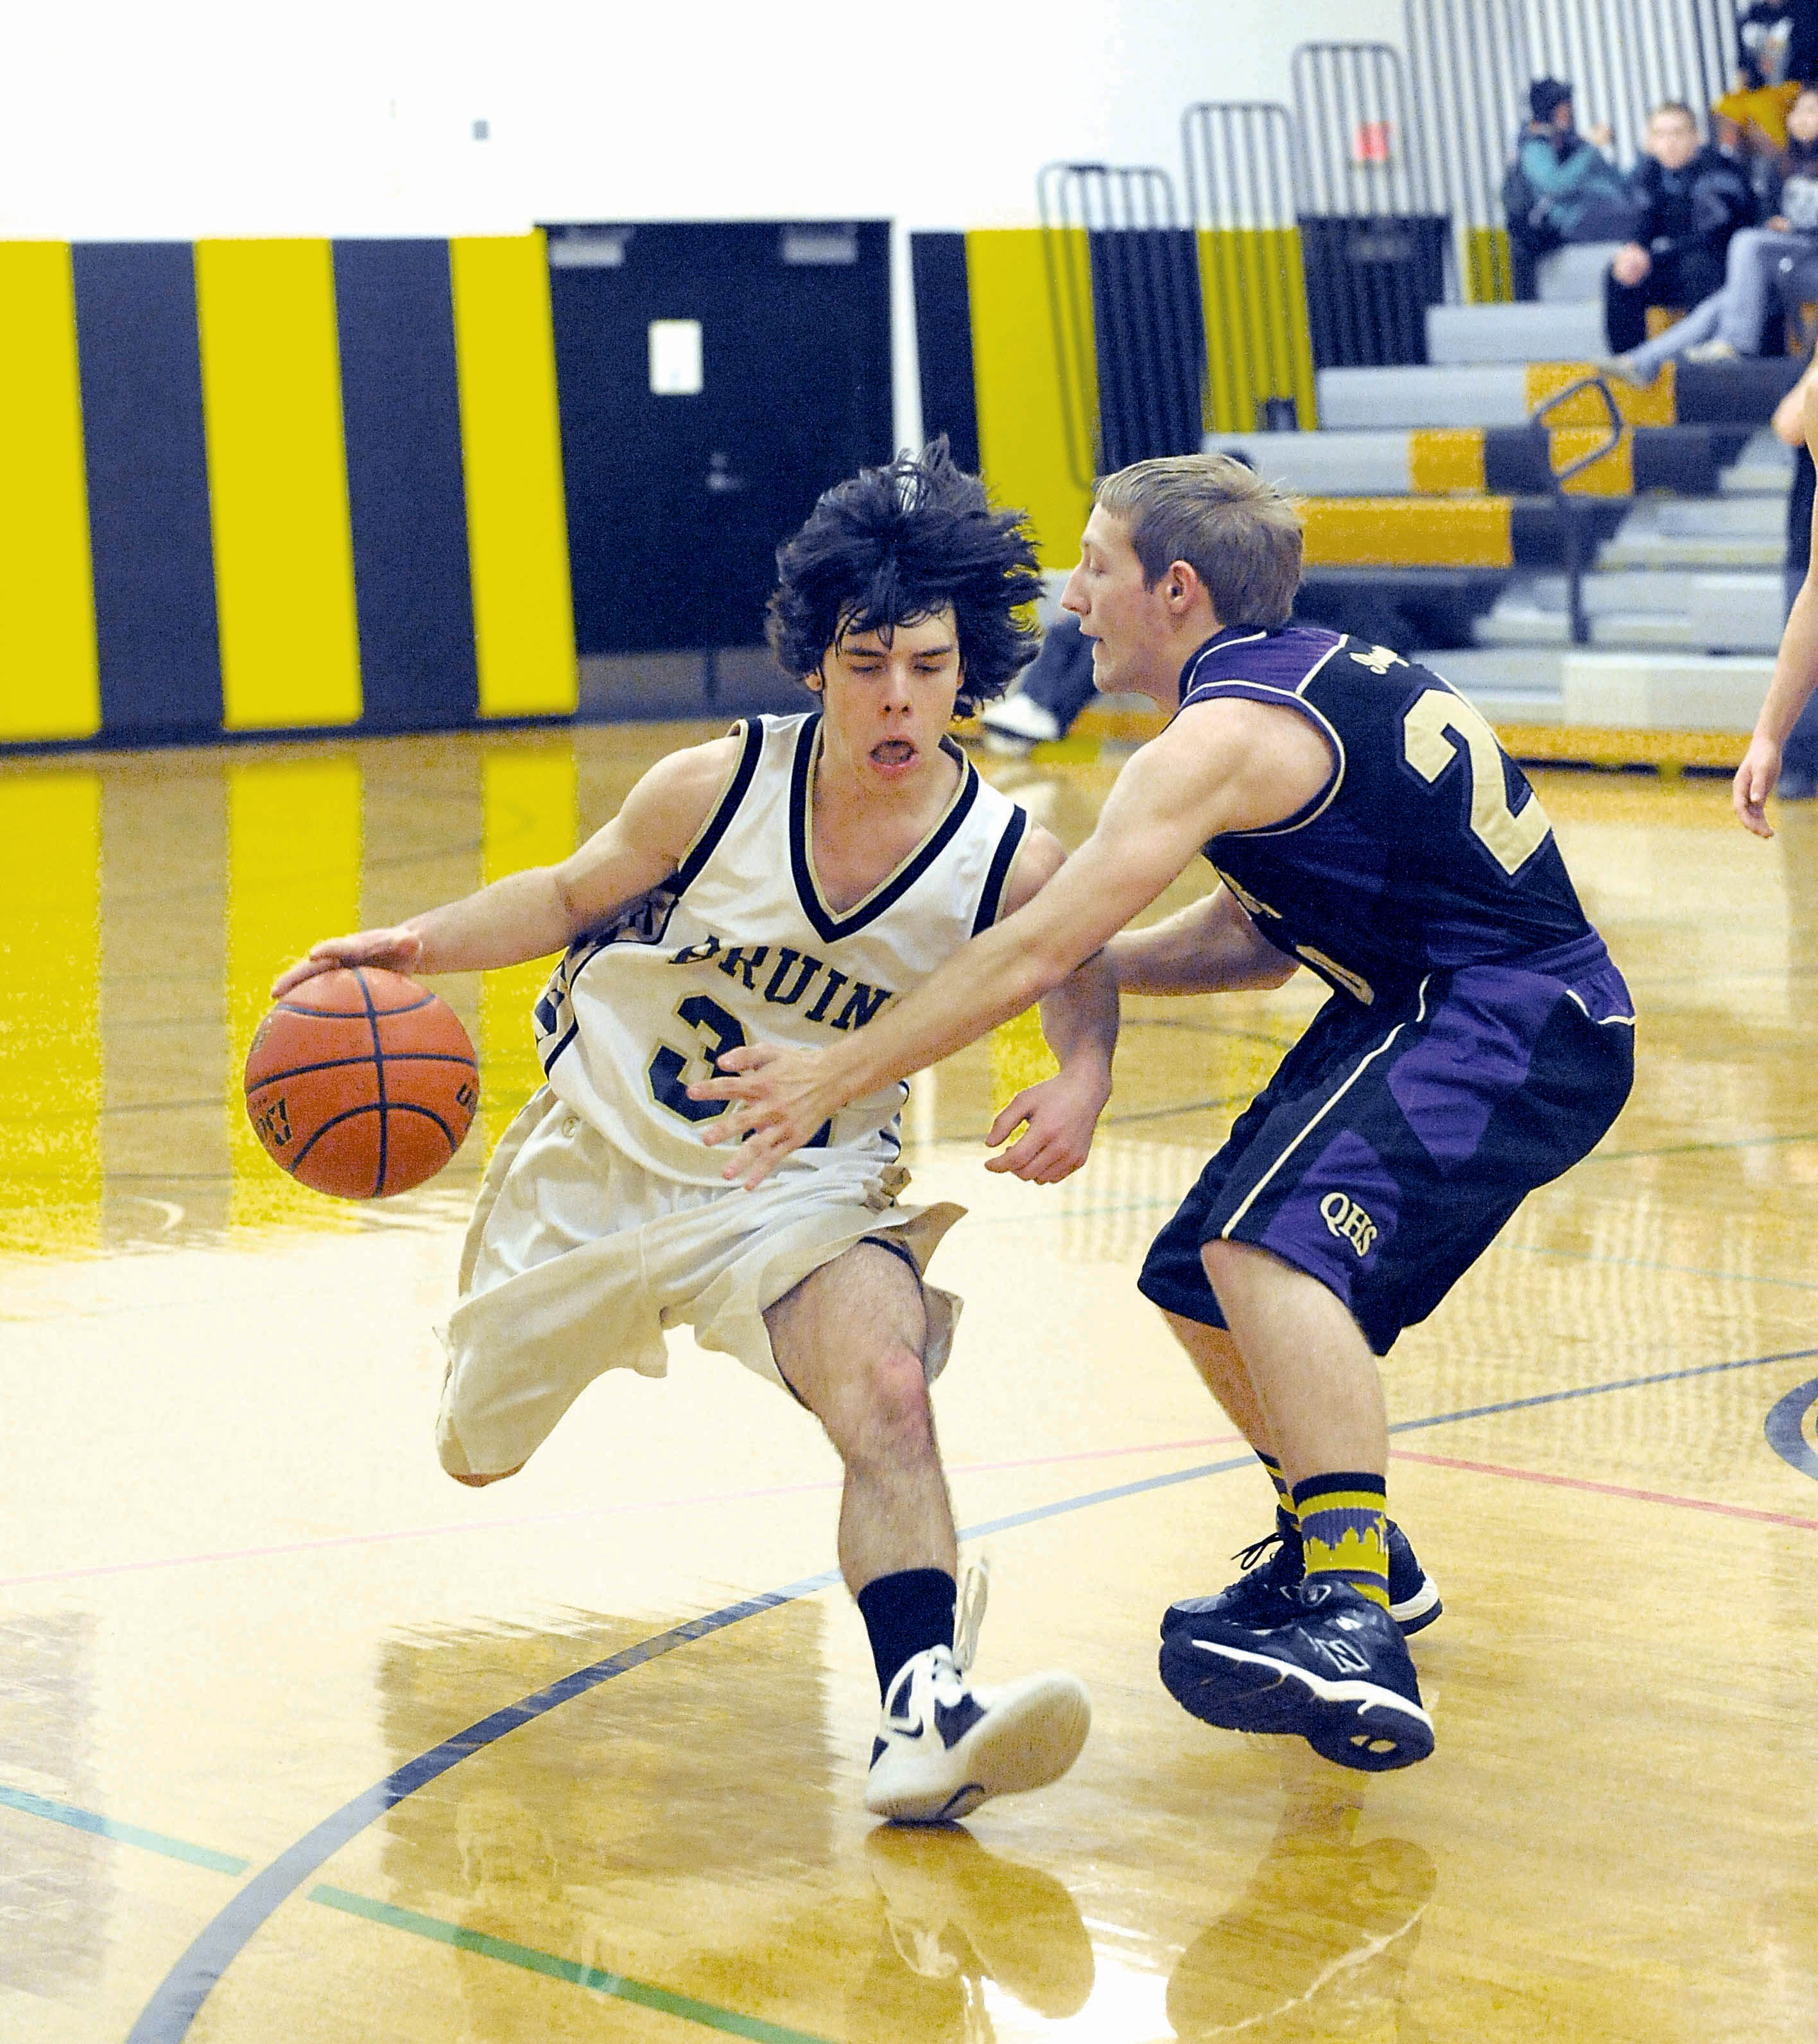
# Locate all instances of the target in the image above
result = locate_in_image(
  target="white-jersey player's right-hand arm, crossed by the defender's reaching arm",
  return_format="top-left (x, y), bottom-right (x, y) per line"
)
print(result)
top-left (985, 826), bottom-right (1116, 1186)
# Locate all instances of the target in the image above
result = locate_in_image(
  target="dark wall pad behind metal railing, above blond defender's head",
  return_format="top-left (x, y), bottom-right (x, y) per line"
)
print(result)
top-left (1086, 227), bottom-right (1207, 472)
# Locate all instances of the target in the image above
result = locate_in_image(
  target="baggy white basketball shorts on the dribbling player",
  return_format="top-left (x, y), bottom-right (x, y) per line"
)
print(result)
top-left (436, 1087), bottom-right (965, 1476)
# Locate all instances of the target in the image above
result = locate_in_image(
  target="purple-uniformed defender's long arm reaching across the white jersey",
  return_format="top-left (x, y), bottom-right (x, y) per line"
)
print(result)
top-left (689, 701), bottom-right (1331, 1186)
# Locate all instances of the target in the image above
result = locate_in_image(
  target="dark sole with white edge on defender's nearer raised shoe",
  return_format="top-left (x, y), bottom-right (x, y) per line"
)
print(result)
top-left (1161, 1635), bottom-right (1433, 1774)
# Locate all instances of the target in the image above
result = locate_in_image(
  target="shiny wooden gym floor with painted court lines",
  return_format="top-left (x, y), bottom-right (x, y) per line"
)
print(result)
top-left (0, 728), bottom-right (1818, 2044)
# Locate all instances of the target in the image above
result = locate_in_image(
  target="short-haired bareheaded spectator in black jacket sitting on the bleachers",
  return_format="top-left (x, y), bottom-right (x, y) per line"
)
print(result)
top-left (1604, 100), bottom-right (1754, 359)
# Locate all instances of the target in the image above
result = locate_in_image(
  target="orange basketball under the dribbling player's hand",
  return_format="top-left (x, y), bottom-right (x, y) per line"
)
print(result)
top-left (245, 965), bottom-right (481, 1200)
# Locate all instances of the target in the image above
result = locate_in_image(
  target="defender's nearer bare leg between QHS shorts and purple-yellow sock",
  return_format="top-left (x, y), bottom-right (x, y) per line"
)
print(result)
top-left (1202, 1243), bottom-right (1389, 1484)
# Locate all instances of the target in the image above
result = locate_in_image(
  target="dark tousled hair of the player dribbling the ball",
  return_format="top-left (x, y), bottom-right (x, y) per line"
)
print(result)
top-left (769, 433), bottom-right (1041, 718)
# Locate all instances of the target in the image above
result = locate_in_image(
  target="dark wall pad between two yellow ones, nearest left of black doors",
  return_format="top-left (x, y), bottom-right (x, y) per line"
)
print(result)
top-left (335, 241), bottom-right (478, 730)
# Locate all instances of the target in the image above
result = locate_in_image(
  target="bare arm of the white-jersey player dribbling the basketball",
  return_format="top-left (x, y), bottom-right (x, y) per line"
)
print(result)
top-left (272, 738), bottom-right (738, 1000)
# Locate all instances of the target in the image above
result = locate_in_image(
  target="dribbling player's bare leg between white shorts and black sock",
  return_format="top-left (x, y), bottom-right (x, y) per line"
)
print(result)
top-left (765, 1243), bottom-right (959, 1597)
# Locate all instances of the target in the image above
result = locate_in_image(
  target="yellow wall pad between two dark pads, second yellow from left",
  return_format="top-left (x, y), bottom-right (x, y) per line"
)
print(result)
top-left (196, 241), bottom-right (360, 730)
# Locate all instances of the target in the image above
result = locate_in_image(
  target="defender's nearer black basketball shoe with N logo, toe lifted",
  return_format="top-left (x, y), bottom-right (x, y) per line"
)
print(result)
top-left (1161, 1576), bottom-right (1433, 1774)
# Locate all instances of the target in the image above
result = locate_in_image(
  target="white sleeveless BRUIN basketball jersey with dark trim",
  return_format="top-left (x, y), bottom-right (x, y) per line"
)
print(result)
top-left (536, 711), bottom-right (1028, 1186)
